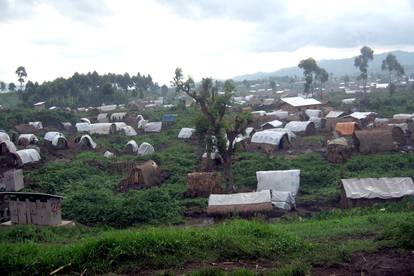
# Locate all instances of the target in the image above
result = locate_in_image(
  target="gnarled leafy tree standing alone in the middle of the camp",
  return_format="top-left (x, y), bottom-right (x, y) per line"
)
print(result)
top-left (172, 68), bottom-right (249, 191)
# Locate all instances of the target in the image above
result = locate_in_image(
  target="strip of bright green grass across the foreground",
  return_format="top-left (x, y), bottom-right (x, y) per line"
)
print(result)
top-left (0, 200), bottom-right (414, 275)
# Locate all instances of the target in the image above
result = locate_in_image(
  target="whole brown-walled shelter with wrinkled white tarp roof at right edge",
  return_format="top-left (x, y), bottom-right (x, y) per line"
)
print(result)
top-left (341, 177), bottom-right (414, 208)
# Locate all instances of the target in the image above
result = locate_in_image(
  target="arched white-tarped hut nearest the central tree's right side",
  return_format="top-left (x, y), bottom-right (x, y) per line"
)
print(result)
top-left (249, 130), bottom-right (290, 154)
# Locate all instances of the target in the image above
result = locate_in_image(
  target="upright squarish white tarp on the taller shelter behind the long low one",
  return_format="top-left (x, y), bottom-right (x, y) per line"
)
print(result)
top-left (256, 170), bottom-right (300, 196)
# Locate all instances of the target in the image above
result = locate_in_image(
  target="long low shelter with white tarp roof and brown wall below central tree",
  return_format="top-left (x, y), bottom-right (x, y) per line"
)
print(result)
top-left (207, 190), bottom-right (273, 215)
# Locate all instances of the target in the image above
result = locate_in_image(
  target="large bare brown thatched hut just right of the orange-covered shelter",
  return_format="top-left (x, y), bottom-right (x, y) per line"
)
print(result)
top-left (354, 127), bottom-right (406, 153)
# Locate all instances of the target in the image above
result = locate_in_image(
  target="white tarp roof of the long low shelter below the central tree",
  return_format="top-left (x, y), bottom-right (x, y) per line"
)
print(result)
top-left (208, 190), bottom-right (271, 206)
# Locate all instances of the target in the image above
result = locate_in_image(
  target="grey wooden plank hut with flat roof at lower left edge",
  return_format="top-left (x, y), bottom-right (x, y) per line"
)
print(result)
top-left (0, 192), bottom-right (62, 226)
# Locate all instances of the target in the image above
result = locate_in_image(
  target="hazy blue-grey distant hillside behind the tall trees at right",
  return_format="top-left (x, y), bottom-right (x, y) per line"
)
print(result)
top-left (233, 51), bottom-right (414, 81)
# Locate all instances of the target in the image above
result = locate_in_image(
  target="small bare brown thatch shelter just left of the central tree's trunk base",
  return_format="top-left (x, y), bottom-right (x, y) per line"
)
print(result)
top-left (187, 172), bottom-right (222, 197)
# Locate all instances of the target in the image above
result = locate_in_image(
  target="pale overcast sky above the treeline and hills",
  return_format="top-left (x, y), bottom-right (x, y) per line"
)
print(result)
top-left (0, 0), bottom-right (414, 84)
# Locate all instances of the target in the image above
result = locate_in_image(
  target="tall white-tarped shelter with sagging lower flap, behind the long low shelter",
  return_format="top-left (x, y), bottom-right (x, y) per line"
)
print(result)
top-left (256, 170), bottom-right (300, 210)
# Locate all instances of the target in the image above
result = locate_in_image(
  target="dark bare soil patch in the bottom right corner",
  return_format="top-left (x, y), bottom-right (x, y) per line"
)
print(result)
top-left (313, 248), bottom-right (414, 276)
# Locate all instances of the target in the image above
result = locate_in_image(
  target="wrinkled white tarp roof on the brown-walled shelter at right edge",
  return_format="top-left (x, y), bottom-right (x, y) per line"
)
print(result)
top-left (341, 177), bottom-right (414, 199)
